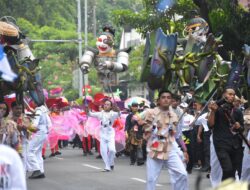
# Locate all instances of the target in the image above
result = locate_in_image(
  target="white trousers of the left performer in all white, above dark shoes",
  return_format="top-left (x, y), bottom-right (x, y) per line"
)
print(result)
top-left (28, 133), bottom-right (47, 173)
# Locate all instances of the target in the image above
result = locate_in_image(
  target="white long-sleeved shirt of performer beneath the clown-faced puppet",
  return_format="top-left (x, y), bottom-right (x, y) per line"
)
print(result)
top-left (89, 110), bottom-right (119, 138)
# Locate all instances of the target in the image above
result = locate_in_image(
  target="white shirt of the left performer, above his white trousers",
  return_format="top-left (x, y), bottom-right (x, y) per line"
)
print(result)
top-left (33, 105), bottom-right (52, 133)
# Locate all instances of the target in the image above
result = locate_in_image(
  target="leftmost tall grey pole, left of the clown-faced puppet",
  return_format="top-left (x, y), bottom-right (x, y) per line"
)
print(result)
top-left (77, 0), bottom-right (83, 97)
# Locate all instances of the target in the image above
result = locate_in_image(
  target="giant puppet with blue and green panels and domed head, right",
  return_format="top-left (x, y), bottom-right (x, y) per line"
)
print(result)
top-left (141, 14), bottom-right (250, 100)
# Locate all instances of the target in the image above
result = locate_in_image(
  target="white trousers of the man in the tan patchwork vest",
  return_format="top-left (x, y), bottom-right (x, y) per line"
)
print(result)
top-left (147, 147), bottom-right (188, 190)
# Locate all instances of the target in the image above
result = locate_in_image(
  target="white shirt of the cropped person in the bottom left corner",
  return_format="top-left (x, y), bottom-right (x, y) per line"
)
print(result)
top-left (0, 145), bottom-right (27, 190)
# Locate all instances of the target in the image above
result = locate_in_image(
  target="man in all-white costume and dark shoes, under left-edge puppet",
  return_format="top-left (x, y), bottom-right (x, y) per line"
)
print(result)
top-left (28, 105), bottom-right (51, 179)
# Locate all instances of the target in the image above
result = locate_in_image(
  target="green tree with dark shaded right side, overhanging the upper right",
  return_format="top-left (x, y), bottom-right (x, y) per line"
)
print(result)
top-left (113, 0), bottom-right (250, 57)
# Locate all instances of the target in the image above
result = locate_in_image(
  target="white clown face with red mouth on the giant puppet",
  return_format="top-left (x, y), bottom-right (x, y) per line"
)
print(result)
top-left (96, 35), bottom-right (113, 53)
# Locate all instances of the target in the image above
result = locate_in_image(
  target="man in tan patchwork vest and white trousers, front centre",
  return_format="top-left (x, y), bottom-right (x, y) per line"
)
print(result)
top-left (141, 91), bottom-right (188, 190)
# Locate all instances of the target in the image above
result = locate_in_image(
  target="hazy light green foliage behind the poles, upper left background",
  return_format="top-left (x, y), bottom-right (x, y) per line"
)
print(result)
top-left (0, 0), bottom-right (145, 100)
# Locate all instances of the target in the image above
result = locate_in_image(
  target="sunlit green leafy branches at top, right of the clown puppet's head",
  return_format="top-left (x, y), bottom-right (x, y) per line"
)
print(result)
top-left (112, 0), bottom-right (197, 37)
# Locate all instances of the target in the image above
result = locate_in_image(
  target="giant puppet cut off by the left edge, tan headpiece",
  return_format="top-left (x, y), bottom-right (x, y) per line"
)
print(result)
top-left (0, 17), bottom-right (44, 105)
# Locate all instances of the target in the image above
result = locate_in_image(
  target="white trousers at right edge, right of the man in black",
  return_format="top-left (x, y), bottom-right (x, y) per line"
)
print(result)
top-left (241, 131), bottom-right (250, 182)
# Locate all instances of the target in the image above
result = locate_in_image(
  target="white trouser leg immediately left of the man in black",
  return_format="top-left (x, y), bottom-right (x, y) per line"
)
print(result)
top-left (210, 135), bottom-right (222, 187)
